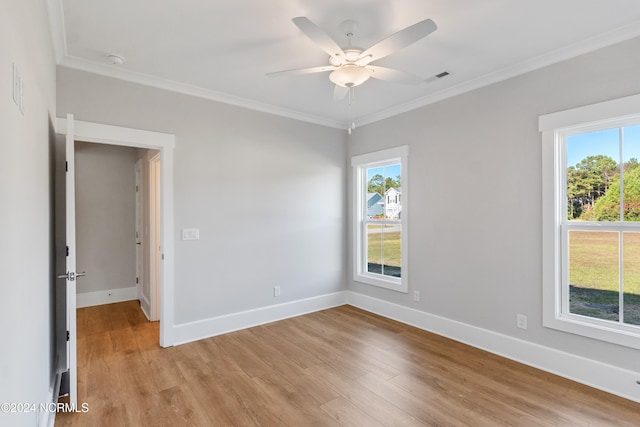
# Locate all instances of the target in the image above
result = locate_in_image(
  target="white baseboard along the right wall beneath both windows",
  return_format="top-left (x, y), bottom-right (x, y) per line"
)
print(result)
top-left (346, 291), bottom-right (640, 402)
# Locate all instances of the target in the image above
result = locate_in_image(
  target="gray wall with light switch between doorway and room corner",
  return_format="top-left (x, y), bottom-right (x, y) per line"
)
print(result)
top-left (57, 67), bottom-right (347, 324)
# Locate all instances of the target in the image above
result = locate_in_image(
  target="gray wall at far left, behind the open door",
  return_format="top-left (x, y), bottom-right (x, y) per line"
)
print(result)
top-left (0, 0), bottom-right (56, 426)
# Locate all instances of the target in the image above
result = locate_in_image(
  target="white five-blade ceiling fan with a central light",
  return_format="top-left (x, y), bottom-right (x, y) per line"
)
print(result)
top-left (267, 16), bottom-right (438, 100)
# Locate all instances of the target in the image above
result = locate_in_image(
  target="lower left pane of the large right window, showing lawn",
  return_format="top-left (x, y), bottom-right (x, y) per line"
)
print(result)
top-left (568, 231), bottom-right (620, 321)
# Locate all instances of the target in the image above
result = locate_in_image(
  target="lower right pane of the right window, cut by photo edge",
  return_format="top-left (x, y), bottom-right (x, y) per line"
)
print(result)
top-left (622, 232), bottom-right (640, 325)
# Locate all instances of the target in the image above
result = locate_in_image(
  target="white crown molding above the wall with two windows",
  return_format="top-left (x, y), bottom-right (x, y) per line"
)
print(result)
top-left (358, 21), bottom-right (640, 126)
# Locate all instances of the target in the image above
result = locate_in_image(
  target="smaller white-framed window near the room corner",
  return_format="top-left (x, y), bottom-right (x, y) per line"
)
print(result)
top-left (352, 146), bottom-right (409, 292)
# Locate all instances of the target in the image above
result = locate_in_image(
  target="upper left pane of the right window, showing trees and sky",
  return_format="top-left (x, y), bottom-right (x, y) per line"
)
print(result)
top-left (566, 129), bottom-right (620, 221)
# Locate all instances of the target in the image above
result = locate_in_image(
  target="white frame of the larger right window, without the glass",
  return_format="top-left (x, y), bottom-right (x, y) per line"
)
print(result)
top-left (539, 95), bottom-right (640, 349)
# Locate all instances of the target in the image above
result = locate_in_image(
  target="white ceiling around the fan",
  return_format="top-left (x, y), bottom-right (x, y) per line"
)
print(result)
top-left (47, 0), bottom-right (640, 128)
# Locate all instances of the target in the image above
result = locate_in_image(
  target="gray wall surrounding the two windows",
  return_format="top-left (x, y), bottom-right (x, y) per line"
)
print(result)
top-left (348, 39), bottom-right (640, 371)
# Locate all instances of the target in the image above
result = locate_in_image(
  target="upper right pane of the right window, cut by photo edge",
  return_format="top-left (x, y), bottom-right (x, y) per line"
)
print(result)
top-left (618, 125), bottom-right (640, 221)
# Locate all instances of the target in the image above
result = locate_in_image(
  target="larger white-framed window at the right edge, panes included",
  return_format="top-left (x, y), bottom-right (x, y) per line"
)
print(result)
top-left (540, 96), bottom-right (640, 348)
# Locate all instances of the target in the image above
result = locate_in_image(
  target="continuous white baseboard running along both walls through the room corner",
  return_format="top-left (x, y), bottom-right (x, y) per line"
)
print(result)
top-left (168, 291), bottom-right (640, 402)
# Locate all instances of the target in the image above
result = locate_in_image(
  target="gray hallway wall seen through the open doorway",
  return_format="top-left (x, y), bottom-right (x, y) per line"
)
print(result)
top-left (75, 142), bottom-right (138, 293)
